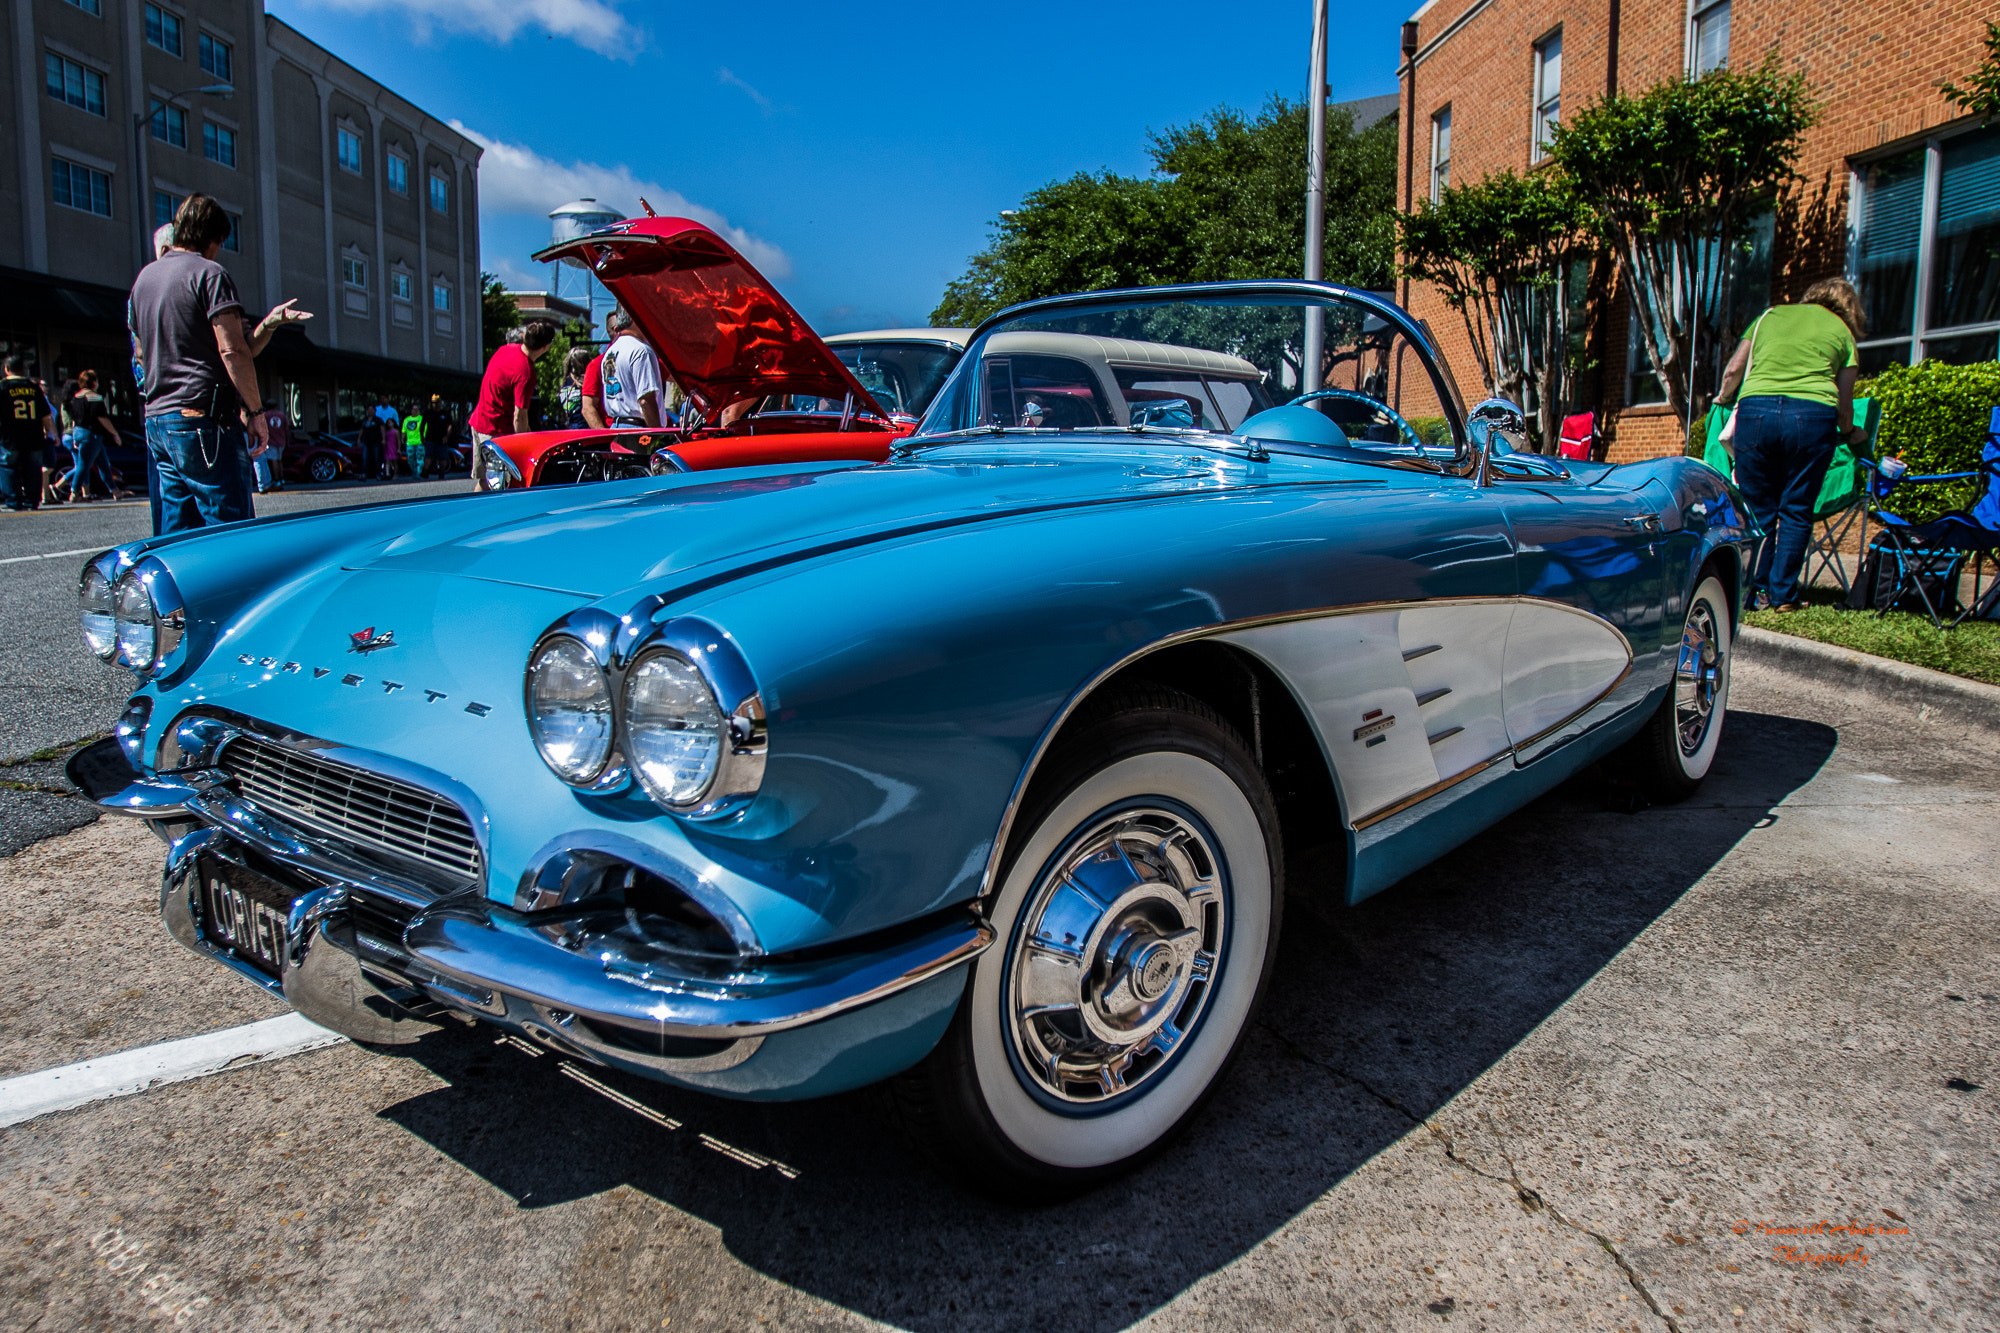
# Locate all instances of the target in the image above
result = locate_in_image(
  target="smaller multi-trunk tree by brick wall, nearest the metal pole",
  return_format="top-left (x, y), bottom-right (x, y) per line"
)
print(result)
top-left (1400, 170), bottom-right (1598, 448)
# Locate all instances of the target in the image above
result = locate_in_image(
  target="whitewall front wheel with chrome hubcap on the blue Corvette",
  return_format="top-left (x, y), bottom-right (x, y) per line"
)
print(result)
top-left (892, 689), bottom-right (1282, 1201)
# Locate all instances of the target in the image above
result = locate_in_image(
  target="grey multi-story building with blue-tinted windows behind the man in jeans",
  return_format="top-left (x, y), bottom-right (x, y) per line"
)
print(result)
top-left (0, 0), bottom-right (480, 428)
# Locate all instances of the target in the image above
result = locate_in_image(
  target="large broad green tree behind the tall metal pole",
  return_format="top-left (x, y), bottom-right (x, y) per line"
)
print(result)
top-left (930, 98), bottom-right (1396, 324)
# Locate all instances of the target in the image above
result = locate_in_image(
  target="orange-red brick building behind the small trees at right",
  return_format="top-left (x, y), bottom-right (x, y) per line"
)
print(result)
top-left (1398, 0), bottom-right (2000, 460)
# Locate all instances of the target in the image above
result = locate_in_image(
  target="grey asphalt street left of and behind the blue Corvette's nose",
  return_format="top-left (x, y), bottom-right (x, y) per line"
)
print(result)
top-left (0, 478), bottom-right (472, 855)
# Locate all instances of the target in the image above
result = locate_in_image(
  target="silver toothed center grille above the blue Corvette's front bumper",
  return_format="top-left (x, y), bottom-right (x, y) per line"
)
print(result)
top-left (220, 737), bottom-right (480, 881)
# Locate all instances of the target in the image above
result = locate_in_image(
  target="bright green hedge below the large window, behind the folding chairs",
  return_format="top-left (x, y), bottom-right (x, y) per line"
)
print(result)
top-left (1854, 360), bottom-right (2000, 522)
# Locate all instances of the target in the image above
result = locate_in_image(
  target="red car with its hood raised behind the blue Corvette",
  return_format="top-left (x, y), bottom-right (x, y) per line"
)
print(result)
top-left (484, 218), bottom-right (964, 490)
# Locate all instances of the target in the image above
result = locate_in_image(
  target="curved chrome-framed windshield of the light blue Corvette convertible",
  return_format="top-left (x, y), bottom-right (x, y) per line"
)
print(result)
top-left (916, 288), bottom-right (1456, 456)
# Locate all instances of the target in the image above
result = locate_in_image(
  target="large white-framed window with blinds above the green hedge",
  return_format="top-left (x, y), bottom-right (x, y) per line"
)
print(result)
top-left (1856, 126), bottom-right (2000, 374)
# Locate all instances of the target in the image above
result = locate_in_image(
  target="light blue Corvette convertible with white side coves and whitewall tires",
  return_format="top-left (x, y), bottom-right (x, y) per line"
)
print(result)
top-left (70, 282), bottom-right (1756, 1197)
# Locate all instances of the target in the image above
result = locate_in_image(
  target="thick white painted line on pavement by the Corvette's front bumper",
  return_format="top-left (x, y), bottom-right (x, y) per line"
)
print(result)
top-left (0, 1013), bottom-right (346, 1125)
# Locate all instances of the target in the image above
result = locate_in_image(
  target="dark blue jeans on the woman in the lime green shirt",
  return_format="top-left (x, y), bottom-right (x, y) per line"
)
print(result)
top-left (1734, 394), bottom-right (1840, 604)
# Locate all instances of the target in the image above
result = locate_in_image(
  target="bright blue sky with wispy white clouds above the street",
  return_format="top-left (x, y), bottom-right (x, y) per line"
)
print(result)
top-left (268, 0), bottom-right (1414, 332)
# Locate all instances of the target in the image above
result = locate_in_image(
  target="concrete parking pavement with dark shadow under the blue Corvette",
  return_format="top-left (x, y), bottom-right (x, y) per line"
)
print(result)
top-left (0, 664), bottom-right (2000, 1333)
